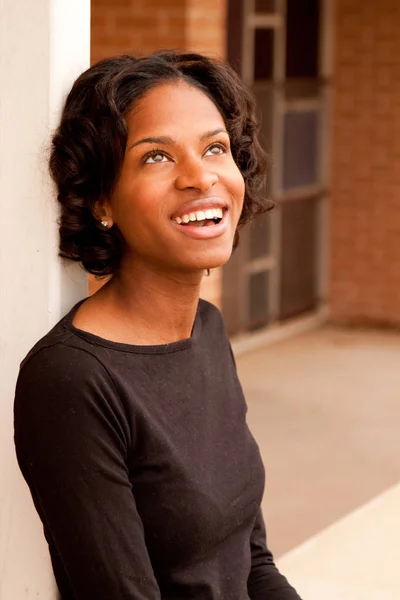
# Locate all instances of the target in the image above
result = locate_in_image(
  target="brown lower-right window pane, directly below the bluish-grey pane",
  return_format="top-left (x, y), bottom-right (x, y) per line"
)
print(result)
top-left (280, 198), bottom-right (318, 319)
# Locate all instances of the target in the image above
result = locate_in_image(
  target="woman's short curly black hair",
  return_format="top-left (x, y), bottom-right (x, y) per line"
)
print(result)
top-left (49, 50), bottom-right (272, 276)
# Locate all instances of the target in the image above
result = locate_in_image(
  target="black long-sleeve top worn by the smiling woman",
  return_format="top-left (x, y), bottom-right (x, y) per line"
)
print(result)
top-left (15, 300), bottom-right (299, 600)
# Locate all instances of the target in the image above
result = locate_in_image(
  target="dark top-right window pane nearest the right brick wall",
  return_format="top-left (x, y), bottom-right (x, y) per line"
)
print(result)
top-left (286, 0), bottom-right (320, 78)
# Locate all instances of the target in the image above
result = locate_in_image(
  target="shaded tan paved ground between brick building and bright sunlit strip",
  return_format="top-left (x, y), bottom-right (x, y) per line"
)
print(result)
top-left (237, 326), bottom-right (400, 556)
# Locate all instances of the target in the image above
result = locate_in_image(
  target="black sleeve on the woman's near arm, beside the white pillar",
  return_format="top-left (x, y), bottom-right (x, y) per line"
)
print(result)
top-left (14, 344), bottom-right (161, 600)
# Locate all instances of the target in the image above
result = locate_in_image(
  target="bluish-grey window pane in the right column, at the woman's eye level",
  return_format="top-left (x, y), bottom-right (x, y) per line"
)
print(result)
top-left (283, 110), bottom-right (319, 190)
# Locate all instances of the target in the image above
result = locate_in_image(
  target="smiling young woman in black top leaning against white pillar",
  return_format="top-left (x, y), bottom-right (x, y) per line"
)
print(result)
top-left (15, 52), bottom-right (299, 600)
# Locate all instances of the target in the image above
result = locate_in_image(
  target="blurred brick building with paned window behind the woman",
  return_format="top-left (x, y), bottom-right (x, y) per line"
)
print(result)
top-left (91, 0), bottom-right (400, 334)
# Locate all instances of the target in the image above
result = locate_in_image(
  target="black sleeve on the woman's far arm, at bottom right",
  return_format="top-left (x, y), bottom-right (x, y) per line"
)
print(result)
top-left (247, 509), bottom-right (301, 600)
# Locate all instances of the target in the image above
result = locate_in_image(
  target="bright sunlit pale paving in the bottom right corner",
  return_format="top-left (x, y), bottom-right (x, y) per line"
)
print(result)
top-left (278, 484), bottom-right (400, 600)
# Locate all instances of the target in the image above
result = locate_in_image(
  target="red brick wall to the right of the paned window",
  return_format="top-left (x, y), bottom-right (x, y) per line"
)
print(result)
top-left (331, 0), bottom-right (400, 324)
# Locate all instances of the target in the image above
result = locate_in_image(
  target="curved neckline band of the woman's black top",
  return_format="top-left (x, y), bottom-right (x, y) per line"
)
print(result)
top-left (63, 298), bottom-right (202, 354)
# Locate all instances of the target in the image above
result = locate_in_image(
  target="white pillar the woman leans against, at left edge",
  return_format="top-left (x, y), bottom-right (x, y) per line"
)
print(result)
top-left (0, 0), bottom-right (90, 600)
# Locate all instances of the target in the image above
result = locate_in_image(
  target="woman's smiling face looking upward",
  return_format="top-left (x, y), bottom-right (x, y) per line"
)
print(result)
top-left (106, 82), bottom-right (244, 272)
